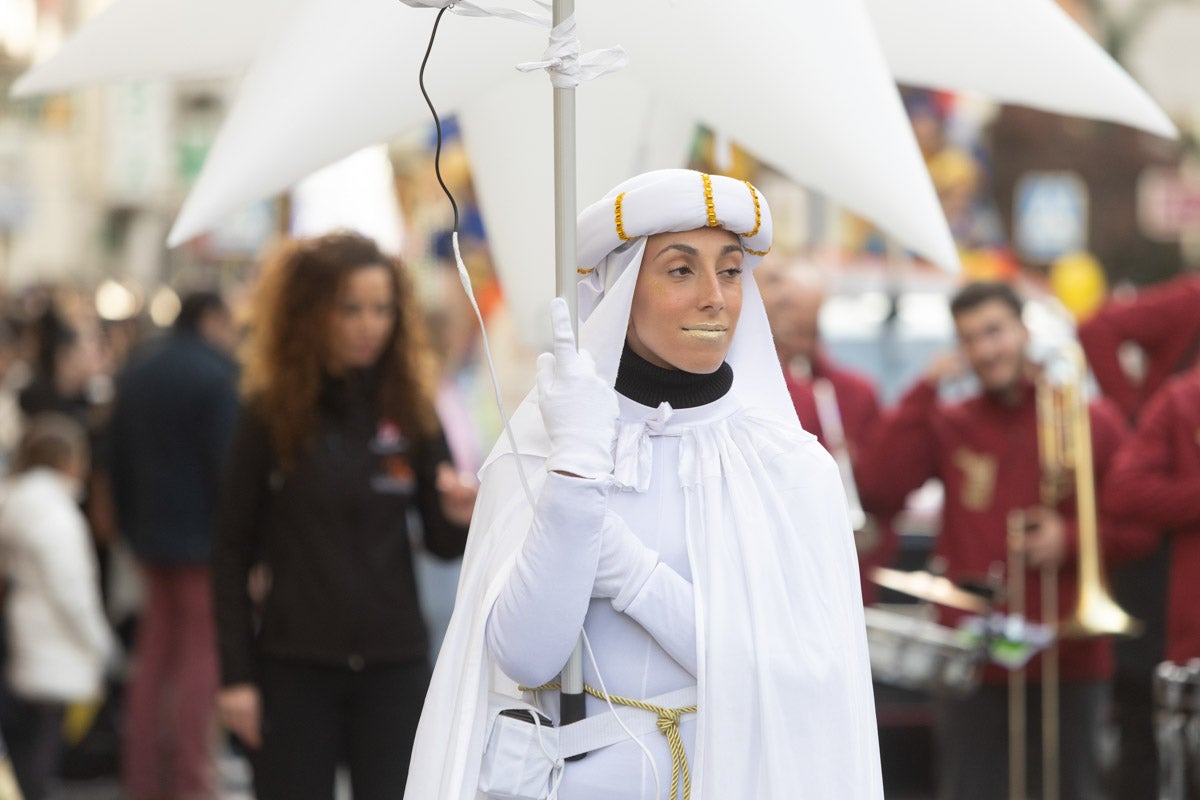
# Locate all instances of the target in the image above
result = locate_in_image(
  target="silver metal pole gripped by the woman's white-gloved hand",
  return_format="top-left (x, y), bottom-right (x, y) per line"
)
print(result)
top-left (553, 0), bottom-right (586, 758)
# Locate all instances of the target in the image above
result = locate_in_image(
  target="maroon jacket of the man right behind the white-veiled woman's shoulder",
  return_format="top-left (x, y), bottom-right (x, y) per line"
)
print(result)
top-left (784, 354), bottom-right (900, 604)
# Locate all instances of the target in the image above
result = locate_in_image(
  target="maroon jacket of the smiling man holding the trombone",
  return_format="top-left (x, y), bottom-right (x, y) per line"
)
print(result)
top-left (859, 381), bottom-right (1154, 682)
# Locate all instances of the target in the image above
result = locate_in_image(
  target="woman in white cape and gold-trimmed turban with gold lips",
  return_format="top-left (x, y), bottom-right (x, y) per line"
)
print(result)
top-left (406, 169), bottom-right (882, 800)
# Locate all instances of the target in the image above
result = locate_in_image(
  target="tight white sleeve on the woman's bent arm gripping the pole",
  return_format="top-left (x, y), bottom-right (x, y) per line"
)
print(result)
top-left (486, 473), bottom-right (608, 686)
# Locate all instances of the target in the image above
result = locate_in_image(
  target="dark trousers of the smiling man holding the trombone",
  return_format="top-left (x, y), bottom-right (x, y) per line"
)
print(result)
top-left (937, 681), bottom-right (1104, 800)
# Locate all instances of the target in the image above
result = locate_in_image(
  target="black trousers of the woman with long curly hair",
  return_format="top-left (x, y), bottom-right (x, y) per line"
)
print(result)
top-left (253, 658), bottom-right (430, 800)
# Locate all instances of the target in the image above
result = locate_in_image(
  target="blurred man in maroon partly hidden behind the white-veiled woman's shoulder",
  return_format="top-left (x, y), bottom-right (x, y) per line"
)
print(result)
top-left (762, 263), bottom-right (900, 604)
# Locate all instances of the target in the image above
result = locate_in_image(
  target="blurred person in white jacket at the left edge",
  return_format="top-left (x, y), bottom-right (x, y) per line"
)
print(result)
top-left (0, 413), bottom-right (115, 800)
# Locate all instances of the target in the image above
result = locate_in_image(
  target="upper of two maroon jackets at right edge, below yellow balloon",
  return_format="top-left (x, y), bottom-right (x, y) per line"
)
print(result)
top-left (1079, 275), bottom-right (1200, 420)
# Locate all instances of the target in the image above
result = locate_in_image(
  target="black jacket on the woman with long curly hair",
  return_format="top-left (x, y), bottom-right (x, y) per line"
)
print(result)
top-left (212, 374), bottom-right (467, 686)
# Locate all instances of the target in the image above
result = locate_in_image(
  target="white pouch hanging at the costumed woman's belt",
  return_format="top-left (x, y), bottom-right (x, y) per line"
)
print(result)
top-left (479, 694), bottom-right (563, 800)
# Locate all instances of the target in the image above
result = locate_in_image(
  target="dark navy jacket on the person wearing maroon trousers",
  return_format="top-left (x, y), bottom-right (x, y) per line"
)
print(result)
top-left (108, 331), bottom-right (238, 565)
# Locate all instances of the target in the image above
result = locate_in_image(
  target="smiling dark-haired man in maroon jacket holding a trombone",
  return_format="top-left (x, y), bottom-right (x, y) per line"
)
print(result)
top-left (859, 283), bottom-right (1152, 800)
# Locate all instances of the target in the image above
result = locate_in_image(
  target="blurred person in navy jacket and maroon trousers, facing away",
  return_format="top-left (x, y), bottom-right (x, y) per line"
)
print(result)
top-left (109, 291), bottom-right (238, 800)
